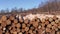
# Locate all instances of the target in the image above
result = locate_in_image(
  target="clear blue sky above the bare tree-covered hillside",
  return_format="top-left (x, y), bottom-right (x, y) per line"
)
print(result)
top-left (0, 0), bottom-right (47, 10)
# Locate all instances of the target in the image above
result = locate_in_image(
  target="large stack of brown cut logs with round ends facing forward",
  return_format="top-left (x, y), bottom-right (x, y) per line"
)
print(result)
top-left (0, 15), bottom-right (60, 34)
